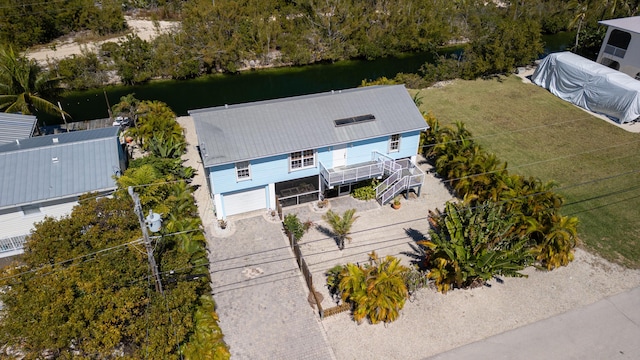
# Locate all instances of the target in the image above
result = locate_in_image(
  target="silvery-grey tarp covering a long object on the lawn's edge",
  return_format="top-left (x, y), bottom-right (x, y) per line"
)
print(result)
top-left (531, 52), bottom-right (640, 124)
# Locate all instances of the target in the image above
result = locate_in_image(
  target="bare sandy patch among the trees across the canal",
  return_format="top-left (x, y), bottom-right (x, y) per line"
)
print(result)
top-left (26, 16), bottom-right (179, 64)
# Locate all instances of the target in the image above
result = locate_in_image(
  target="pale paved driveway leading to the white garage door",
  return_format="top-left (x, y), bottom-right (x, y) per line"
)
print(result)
top-left (208, 215), bottom-right (335, 360)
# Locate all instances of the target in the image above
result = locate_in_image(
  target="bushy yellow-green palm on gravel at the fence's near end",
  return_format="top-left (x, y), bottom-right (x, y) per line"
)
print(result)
top-left (332, 252), bottom-right (409, 324)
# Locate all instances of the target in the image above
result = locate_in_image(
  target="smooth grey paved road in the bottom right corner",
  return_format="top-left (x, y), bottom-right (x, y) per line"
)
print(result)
top-left (430, 288), bottom-right (640, 360)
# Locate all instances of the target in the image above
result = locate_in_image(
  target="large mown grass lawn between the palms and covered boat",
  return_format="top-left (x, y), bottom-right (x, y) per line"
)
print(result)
top-left (411, 76), bottom-right (640, 268)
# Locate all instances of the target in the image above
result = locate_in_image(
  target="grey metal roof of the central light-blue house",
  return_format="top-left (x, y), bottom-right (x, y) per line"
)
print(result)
top-left (189, 85), bottom-right (428, 166)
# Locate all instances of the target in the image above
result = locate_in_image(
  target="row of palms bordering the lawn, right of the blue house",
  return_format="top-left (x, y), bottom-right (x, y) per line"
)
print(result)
top-left (423, 117), bottom-right (580, 276)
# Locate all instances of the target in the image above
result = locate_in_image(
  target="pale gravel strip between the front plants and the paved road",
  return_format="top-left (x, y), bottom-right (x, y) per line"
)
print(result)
top-left (322, 249), bottom-right (640, 359)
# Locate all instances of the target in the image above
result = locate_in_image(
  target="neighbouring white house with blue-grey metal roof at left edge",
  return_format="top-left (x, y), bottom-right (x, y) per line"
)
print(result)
top-left (0, 127), bottom-right (126, 257)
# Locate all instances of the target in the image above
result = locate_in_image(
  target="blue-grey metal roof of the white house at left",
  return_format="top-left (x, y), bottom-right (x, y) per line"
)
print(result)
top-left (0, 127), bottom-right (120, 209)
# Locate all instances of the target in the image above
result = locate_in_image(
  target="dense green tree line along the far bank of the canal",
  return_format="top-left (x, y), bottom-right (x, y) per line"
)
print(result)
top-left (0, 0), bottom-right (639, 89)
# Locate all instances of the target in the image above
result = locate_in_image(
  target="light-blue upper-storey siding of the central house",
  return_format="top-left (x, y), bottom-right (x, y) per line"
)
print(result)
top-left (209, 131), bottom-right (420, 194)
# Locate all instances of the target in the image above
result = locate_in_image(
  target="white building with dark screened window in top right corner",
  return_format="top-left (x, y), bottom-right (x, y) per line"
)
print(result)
top-left (596, 16), bottom-right (640, 80)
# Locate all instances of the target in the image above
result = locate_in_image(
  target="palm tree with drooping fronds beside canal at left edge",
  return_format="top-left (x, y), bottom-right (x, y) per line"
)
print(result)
top-left (0, 46), bottom-right (70, 117)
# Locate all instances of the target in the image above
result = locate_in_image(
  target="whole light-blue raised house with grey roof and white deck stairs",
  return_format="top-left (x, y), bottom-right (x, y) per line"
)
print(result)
top-left (189, 85), bottom-right (428, 219)
